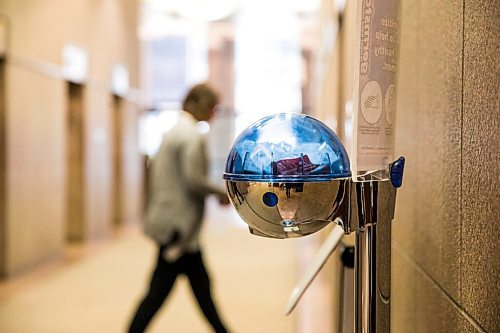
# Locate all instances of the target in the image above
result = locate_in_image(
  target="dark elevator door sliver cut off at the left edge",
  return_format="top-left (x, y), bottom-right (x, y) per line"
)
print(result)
top-left (0, 57), bottom-right (7, 277)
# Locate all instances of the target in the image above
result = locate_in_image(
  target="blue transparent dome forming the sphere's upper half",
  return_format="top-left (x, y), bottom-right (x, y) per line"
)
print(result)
top-left (223, 113), bottom-right (351, 183)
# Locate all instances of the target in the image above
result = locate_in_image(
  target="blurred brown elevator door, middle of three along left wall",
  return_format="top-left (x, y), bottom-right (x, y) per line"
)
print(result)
top-left (66, 82), bottom-right (85, 241)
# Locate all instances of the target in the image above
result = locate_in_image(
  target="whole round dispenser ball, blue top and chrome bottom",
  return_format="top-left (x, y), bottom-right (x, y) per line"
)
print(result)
top-left (224, 113), bottom-right (351, 238)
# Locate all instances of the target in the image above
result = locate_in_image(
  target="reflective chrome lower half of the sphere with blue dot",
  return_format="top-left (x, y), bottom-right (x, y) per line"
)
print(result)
top-left (226, 179), bottom-right (346, 238)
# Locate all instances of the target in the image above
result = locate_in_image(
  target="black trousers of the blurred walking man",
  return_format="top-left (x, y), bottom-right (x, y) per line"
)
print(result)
top-left (129, 246), bottom-right (227, 333)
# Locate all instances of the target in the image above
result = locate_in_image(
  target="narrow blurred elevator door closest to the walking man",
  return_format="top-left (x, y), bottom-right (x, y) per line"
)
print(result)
top-left (111, 95), bottom-right (124, 225)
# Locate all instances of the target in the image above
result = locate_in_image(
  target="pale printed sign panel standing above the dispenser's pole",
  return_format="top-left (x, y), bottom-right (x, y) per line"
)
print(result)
top-left (351, 0), bottom-right (401, 181)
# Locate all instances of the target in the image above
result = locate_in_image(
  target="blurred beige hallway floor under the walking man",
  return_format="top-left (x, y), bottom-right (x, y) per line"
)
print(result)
top-left (0, 203), bottom-right (304, 333)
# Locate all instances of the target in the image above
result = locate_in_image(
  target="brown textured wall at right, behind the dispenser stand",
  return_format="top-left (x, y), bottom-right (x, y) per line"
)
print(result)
top-left (310, 0), bottom-right (500, 332)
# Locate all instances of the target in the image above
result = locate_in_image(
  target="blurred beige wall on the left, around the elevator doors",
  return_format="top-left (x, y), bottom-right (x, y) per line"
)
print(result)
top-left (0, 0), bottom-right (142, 276)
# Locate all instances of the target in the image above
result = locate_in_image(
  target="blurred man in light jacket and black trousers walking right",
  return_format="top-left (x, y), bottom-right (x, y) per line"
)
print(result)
top-left (129, 84), bottom-right (229, 333)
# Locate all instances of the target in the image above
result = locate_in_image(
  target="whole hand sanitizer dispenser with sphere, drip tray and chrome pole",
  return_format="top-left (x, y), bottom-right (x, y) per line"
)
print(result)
top-left (223, 113), bottom-right (404, 333)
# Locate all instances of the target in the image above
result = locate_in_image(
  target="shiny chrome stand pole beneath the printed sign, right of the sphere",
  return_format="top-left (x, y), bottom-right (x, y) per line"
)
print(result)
top-left (355, 182), bottom-right (393, 333)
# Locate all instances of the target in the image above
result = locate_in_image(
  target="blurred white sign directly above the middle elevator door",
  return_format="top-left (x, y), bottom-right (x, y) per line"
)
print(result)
top-left (62, 44), bottom-right (89, 83)
